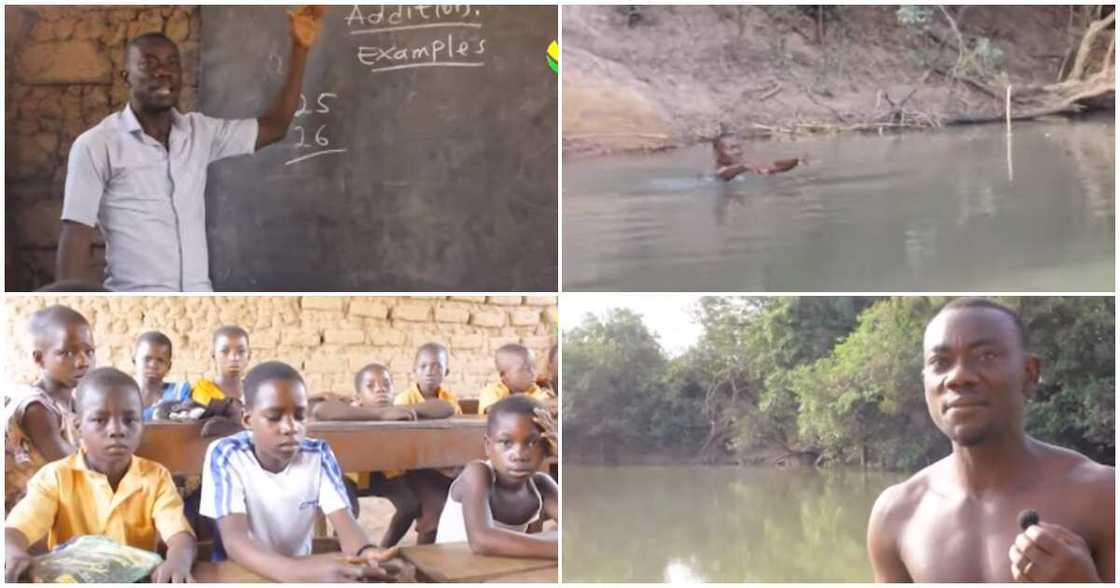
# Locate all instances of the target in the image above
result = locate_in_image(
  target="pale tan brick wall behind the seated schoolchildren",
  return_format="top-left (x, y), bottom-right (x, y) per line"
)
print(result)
top-left (4, 296), bottom-right (559, 398)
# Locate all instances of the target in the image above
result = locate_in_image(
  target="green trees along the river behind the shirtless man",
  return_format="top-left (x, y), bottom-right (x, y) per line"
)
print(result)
top-left (563, 297), bottom-right (1116, 470)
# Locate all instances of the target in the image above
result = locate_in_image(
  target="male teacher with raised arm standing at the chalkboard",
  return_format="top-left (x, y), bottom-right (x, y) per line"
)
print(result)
top-left (55, 7), bottom-right (325, 291)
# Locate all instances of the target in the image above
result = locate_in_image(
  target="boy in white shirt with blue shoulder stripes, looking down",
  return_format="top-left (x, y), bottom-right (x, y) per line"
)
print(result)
top-left (199, 362), bottom-right (394, 582)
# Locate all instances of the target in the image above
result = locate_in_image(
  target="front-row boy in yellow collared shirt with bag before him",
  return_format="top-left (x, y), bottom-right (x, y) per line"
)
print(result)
top-left (4, 367), bottom-right (196, 582)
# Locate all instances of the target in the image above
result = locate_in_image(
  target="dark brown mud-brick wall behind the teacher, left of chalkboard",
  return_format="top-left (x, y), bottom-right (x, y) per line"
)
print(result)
top-left (4, 6), bottom-right (200, 291)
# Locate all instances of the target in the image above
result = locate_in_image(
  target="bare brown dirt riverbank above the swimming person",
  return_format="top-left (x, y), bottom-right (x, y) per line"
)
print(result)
top-left (561, 6), bottom-right (1076, 156)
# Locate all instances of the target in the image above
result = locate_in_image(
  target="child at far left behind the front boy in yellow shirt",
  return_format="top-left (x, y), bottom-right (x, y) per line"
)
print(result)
top-left (4, 306), bottom-right (94, 513)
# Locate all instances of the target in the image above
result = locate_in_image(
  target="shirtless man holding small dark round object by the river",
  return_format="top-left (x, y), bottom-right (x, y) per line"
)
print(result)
top-left (867, 298), bottom-right (1116, 582)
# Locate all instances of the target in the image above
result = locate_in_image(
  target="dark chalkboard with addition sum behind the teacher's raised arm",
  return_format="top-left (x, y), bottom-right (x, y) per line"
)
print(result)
top-left (199, 6), bottom-right (559, 291)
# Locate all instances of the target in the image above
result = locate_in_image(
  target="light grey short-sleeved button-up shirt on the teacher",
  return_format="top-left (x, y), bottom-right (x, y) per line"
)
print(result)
top-left (63, 105), bottom-right (256, 292)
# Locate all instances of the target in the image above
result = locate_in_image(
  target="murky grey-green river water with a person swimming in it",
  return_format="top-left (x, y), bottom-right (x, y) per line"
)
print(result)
top-left (562, 115), bottom-right (1116, 291)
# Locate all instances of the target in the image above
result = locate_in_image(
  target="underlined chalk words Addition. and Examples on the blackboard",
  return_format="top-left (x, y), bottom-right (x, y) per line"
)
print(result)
top-left (346, 4), bottom-right (486, 73)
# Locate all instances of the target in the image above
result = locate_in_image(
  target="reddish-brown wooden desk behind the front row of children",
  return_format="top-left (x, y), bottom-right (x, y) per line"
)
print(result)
top-left (137, 417), bottom-right (486, 475)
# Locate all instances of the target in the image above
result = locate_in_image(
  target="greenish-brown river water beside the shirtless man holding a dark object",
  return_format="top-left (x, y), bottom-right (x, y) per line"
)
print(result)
top-left (561, 464), bottom-right (905, 584)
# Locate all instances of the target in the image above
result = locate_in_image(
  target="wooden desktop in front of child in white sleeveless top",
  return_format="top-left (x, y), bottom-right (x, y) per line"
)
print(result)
top-left (401, 542), bottom-right (557, 584)
